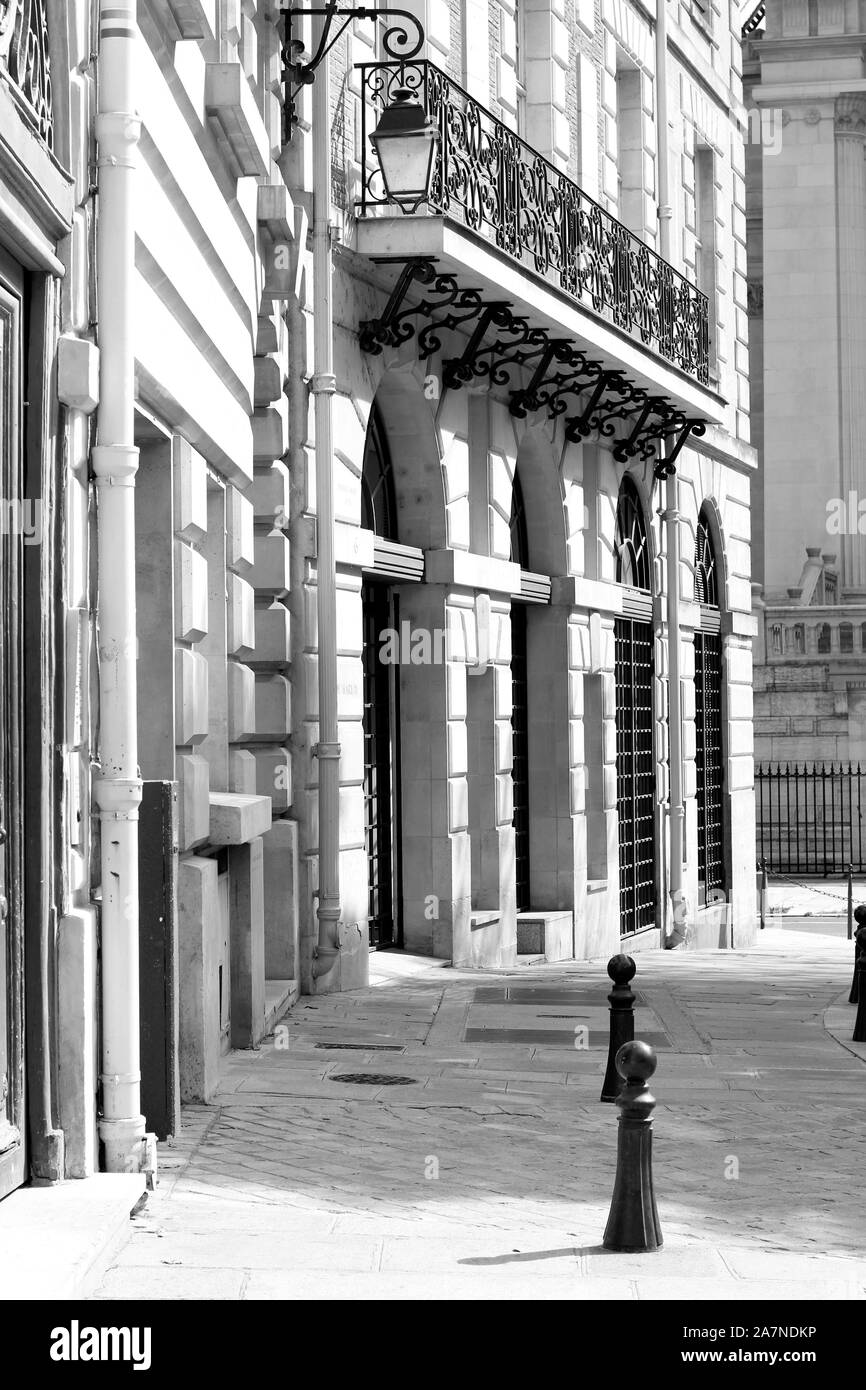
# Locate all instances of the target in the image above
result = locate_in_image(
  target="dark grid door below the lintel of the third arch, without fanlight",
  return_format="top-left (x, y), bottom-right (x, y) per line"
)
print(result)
top-left (614, 619), bottom-right (656, 935)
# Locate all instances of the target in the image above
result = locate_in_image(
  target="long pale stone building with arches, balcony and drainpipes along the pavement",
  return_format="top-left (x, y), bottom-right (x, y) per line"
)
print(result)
top-left (0, 0), bottom-right (755, 1195)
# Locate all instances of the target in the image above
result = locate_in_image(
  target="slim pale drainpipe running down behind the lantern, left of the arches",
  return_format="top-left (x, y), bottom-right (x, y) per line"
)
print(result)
top-left (311, 19), bottom-right (341, 980)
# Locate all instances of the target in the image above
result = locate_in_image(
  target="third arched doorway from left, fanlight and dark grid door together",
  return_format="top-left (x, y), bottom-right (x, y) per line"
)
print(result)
top-left (614, 477), bottom-right (657, 935)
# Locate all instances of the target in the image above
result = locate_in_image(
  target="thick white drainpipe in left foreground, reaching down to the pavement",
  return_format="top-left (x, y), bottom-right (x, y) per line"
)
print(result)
top-left (92, 0), bottom-right (147, 1173)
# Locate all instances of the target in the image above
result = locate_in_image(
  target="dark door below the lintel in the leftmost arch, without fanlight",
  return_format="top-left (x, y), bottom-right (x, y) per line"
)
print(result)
top-left (361, 584), bottom-right (402, 948)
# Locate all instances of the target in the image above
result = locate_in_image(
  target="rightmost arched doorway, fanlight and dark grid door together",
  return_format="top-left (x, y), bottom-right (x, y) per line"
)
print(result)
top-left (695, 510), bottom-right (727, 906)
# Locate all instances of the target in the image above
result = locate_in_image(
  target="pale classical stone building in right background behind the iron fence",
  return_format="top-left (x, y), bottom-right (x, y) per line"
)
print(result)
top-left (745, 0), bottom-right (866, 872)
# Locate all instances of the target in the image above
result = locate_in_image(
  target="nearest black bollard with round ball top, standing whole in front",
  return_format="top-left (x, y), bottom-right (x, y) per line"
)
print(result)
top-left (602, 1043), bottom-right (662, 1252)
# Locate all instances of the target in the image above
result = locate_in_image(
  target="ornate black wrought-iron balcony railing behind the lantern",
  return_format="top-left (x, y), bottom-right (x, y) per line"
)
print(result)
top-left (357, 60), bottom-right (709, 384)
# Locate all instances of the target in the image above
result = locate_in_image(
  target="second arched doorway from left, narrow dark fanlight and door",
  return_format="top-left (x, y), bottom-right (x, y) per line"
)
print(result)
top-left (510, 474), bottom-right (530, 912)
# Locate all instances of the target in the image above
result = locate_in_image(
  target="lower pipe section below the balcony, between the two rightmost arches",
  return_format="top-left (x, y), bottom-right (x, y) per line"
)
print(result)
top-left (662, 461), bottom-right (688, 949)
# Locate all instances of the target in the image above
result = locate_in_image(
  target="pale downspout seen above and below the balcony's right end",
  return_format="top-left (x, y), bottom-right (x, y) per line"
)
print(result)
top-left (656, 0), bottom-right (688, 949)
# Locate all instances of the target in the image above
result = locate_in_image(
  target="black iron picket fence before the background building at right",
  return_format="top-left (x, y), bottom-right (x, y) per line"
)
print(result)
top-left (755, 763), bottom-right (866, 877)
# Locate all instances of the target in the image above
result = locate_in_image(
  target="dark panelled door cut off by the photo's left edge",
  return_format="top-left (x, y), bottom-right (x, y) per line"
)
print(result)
top-left (0, 267), bottom-right (25, 1198)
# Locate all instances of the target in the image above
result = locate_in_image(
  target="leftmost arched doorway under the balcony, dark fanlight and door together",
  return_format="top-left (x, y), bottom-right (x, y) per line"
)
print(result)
top-left (361, 406), bottom-right (402, 949)
